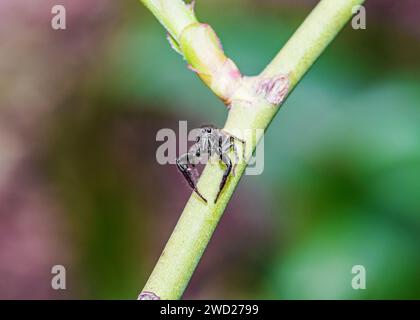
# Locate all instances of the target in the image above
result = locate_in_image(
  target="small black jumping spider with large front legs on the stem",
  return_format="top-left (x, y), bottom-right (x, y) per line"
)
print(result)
top-left (176, 126), bottom-right (245, 203)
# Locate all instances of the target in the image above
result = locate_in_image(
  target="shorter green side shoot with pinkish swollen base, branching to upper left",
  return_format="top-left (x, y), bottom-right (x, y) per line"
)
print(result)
top-left (141, 0), bottom-right (241, 104)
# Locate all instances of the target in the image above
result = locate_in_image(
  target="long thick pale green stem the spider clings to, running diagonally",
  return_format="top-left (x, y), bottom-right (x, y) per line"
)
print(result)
top-left (138, 0), bottom-right (363, 299)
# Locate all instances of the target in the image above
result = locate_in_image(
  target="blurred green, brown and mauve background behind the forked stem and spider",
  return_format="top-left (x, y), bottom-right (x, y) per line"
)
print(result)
top-left (0, 0), bottom-right (420, 299)
